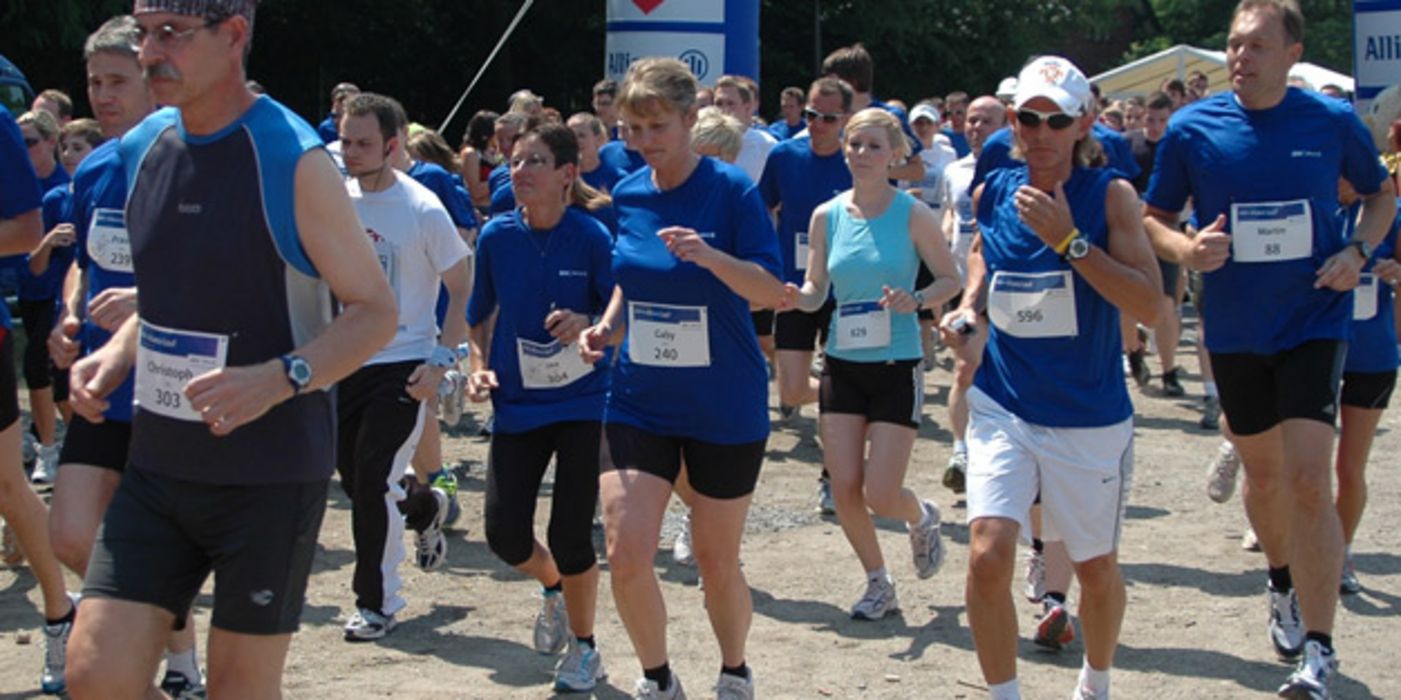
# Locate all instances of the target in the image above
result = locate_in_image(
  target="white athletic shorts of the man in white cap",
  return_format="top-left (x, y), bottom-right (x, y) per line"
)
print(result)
top-left (967, 386), bottom-right (1133, 561)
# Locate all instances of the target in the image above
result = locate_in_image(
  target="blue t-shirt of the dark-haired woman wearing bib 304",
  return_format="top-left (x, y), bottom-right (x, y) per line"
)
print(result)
top-left (467, 207), bottom-right (614, 433)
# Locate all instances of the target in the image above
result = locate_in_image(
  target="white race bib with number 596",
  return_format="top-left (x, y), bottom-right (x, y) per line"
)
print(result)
top-left (988, 270), bottom-right (1080, 337)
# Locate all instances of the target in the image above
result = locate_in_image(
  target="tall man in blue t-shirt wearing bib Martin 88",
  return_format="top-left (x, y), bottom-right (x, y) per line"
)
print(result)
top-left (1145, 1), bottom-right (1395, 699)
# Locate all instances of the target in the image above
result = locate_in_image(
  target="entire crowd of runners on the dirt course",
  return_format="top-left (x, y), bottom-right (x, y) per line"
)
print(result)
top-left (0, 0), bottom-right (1401, 700)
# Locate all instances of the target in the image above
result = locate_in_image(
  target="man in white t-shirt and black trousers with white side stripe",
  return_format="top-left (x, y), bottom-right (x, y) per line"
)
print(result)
top-left (336, 92), bottom-right (471, 641)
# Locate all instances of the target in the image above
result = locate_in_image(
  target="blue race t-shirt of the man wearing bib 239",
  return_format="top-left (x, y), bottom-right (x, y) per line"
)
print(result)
top-left (69, 139), bottom-right (136, 423)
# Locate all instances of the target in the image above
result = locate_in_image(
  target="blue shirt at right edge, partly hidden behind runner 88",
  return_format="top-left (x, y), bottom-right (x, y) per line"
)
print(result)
top-left (1339, 202), bottom-right (1401, 372)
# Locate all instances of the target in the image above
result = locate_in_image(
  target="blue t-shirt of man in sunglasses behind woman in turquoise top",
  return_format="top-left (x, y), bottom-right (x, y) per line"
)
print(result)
top-left (759, 139), bottom-right (852, 284)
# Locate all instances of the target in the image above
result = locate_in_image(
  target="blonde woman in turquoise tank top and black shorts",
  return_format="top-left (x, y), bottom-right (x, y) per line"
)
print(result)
top-left (787, 109), bottom-right (958, 620)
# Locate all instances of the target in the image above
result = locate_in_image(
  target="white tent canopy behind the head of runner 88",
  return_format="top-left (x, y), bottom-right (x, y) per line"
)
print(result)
top-left (1090, 43), bottom-right (1353, 99)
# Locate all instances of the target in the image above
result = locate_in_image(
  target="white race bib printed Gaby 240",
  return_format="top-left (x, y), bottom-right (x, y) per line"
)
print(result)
top-left (628, 301), bottom-right (710, 367)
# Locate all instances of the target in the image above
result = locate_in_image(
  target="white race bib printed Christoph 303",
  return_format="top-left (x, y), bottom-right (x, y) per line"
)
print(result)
top-left (136, 321), bottom-right (228, 421)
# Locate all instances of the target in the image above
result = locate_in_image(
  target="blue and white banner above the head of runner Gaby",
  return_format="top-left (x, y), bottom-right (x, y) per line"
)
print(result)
top-left (604, 0), bottom-right (759, 85)
